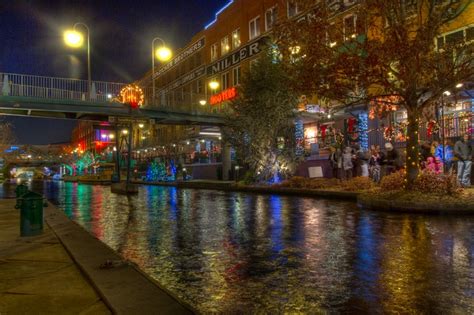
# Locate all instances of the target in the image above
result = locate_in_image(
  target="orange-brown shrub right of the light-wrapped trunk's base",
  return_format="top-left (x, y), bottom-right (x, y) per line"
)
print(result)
top-left (413, 169), bottom-right (462, 195)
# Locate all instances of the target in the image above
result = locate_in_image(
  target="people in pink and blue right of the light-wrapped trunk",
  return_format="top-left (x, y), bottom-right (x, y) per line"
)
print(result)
top-left (420, 134), bottom-right (474, 187)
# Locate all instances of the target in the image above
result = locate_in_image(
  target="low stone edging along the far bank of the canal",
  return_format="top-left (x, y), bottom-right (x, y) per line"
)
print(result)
top-left (131, 181), bottom-right (474, 214)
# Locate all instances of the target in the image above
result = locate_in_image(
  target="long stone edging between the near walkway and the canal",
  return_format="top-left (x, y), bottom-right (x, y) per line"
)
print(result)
top-left (44, 204), bottom-right (196, 314)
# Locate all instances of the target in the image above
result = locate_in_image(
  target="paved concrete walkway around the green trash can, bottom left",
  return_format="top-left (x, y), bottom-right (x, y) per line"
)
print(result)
top-left (0, 199), bottom-right (111, 315)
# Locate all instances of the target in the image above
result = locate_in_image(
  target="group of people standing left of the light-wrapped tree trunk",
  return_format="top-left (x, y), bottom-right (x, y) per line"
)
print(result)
top-left (329, 142), bottom-right (403, 182)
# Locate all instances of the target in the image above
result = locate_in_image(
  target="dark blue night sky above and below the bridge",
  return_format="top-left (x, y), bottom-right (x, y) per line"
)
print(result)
top-left (0, 0), bottom-right (228, 144)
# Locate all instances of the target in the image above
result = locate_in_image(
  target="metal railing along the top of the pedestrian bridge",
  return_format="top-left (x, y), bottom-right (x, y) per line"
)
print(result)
top-left (0, 72), bottom-right (228, 115)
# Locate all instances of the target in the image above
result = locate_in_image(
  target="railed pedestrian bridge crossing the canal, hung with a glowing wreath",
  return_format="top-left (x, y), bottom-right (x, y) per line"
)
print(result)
top-left (0, 72), bottom-right (227, 126)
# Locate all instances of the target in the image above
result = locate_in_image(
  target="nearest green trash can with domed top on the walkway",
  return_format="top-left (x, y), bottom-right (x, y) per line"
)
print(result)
top-left (15, 191), bottom-right (48, 236)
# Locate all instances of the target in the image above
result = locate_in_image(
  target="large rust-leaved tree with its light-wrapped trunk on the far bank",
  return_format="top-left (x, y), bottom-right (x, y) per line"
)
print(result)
top-left (276, 0), bottom-right (474, 188)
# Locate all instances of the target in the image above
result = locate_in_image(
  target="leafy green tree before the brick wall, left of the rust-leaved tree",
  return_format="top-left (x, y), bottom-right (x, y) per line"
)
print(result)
top-left (224, 53), bottom-right (297, 182)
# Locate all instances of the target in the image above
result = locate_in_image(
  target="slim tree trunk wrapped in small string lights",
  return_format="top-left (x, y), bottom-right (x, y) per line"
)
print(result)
top-left (405, 109), bottom-right (420, 190)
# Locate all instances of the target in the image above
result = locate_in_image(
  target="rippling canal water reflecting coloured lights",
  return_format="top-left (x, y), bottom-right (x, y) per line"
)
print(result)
top-left (0, 182), bottom-right (474, 314)
